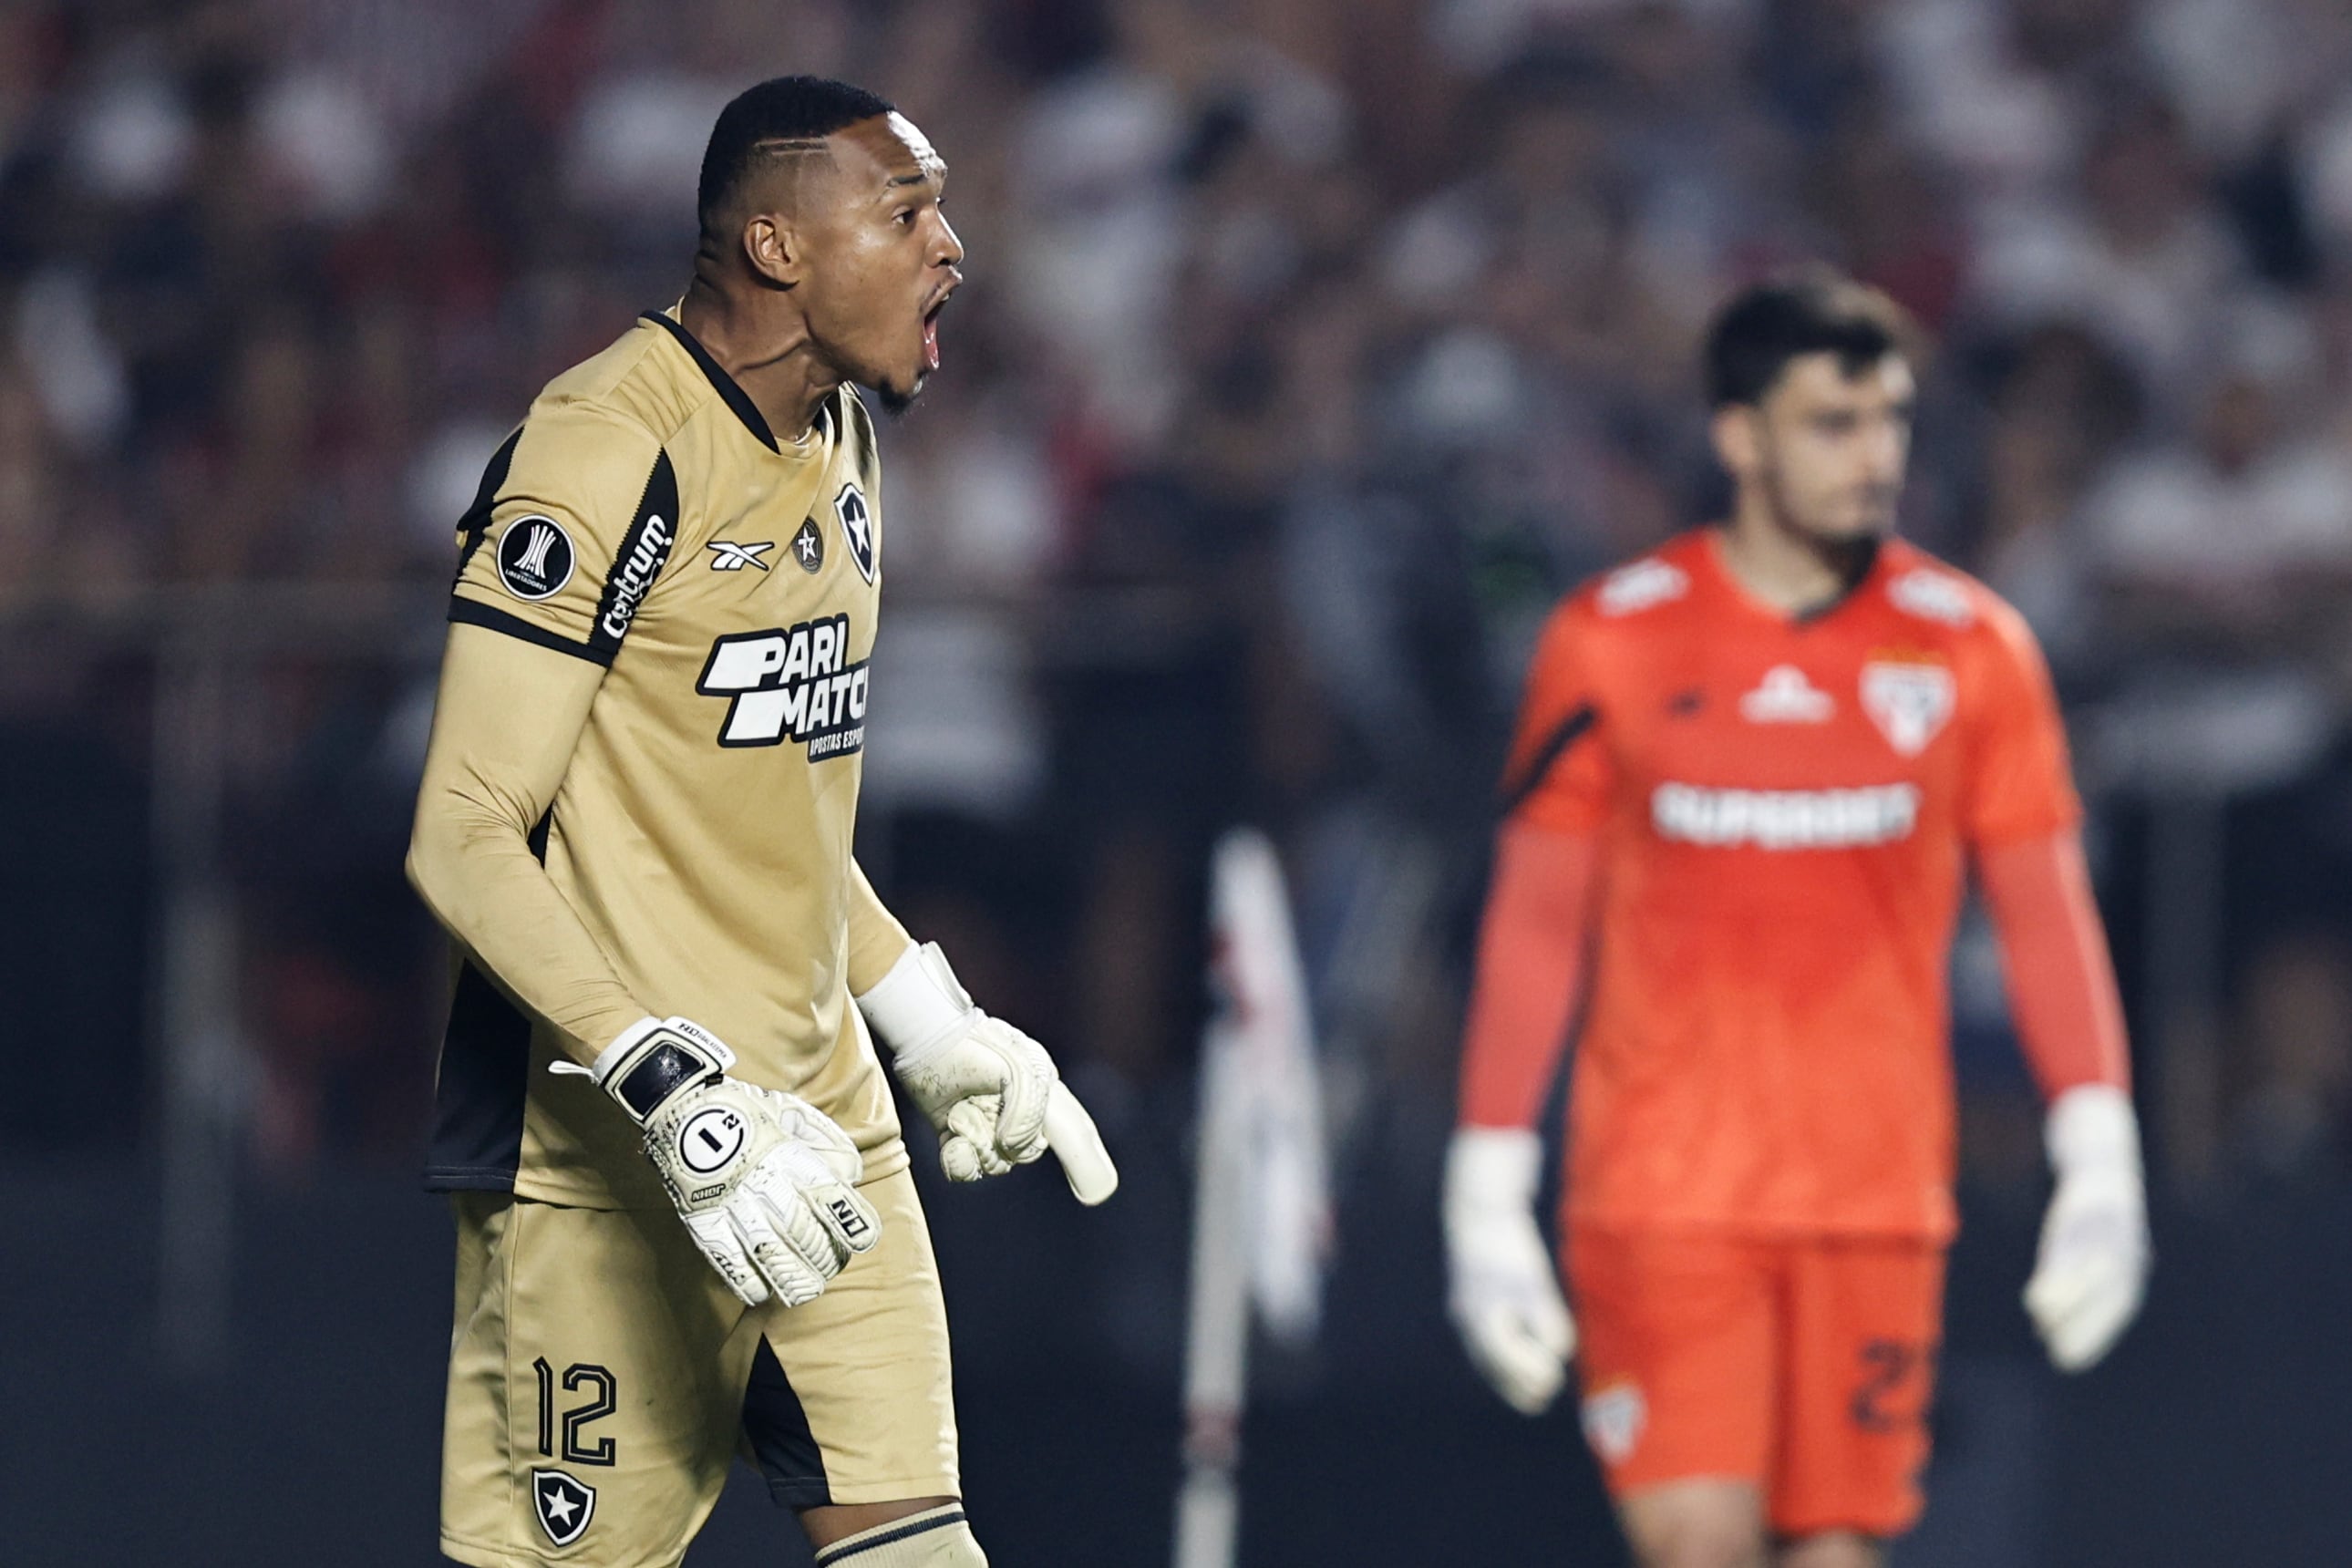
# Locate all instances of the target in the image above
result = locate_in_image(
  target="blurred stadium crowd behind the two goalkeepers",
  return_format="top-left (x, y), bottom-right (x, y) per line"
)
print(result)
top-left (0, 0), bottom-right (2352, 1222)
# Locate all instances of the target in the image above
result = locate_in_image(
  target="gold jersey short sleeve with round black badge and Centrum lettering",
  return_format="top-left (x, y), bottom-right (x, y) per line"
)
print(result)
top-left (449, 405), bottom-right (677, 665)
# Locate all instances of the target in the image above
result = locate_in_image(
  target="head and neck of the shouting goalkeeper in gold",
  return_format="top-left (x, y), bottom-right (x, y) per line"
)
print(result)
top-left (680, 76), bottom-right (965, 425)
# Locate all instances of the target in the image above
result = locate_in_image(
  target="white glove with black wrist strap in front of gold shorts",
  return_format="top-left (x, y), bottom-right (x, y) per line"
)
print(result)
top-left (552, 1018), bottom-right (882, 1307)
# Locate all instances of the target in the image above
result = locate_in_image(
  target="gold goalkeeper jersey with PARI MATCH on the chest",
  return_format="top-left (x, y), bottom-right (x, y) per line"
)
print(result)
top-left (426, 310), bottom-right (905, 1208)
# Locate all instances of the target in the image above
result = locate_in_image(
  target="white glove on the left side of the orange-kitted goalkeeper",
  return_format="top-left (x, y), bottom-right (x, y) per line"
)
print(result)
top-left (1444, 1126), bottom-right (1576, 1415)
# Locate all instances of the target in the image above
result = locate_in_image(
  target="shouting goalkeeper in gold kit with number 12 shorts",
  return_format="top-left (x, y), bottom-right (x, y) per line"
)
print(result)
top-left (409, 77), bottom-right (1118, 1568)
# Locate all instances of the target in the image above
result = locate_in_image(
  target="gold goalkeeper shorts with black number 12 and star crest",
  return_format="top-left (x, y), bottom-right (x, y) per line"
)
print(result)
top-left (442, 1171), bottom-right (960, 1568)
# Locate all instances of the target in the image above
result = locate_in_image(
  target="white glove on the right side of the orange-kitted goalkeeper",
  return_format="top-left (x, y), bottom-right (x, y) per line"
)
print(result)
top-left (2025, 1084), bottom-right (2148, 1373)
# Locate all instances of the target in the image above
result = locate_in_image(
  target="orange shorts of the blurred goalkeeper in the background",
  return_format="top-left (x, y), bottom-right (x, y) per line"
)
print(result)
top-left (1566, 1225), bottom-right (1943, 1537)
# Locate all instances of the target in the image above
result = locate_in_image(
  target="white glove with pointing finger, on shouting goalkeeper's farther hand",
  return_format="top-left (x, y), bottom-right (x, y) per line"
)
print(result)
top-left (856, 943), bottom-right (1119, 1203)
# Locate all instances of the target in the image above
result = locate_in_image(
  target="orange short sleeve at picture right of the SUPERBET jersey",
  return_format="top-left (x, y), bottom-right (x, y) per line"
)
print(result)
top-left (1964, 602), bottom-right (2081, 846)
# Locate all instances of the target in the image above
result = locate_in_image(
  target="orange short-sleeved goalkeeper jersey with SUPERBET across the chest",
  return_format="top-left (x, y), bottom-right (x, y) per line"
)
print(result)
top-left (1505, 531), bottom-right (2079, 1236)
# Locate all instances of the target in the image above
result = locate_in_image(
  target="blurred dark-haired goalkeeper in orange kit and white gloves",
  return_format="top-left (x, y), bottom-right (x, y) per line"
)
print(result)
top-left (1444, 275), bottom-right (2148, 1568)
